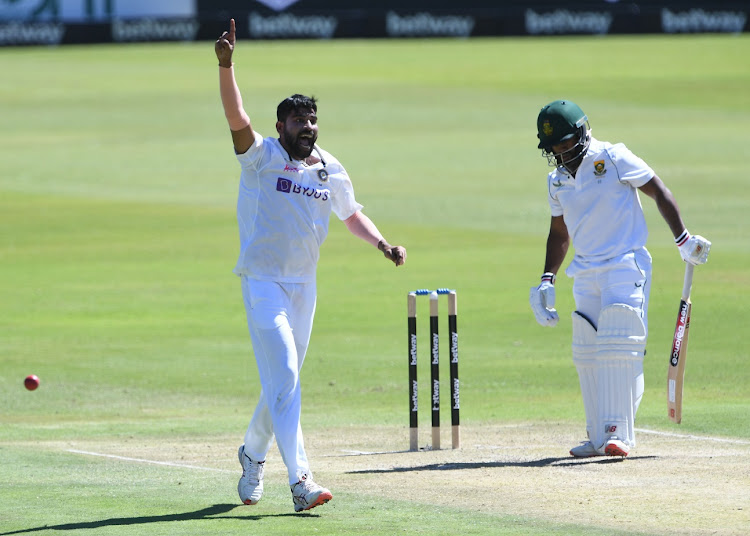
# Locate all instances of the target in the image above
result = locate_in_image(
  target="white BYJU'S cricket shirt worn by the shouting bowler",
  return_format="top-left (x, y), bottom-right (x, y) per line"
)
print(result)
top-left (234, 132), bottom-right (362, 283)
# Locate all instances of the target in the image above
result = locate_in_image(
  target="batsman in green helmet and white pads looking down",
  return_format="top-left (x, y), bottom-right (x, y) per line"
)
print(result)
top-left (529, 100), bottom-right (711, 458)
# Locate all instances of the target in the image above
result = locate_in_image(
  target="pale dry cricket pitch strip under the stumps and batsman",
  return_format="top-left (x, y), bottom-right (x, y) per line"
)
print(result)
top-left (60, 423), bottom-right (750, 536)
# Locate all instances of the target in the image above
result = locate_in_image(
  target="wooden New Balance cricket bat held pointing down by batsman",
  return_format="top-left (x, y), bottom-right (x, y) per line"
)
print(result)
top-left (667, 263), bottom-right (695, 424)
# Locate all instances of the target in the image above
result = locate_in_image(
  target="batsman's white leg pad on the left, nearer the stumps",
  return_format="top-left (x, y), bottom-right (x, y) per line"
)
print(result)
top-left (571, 311), bottom-right (601, 448)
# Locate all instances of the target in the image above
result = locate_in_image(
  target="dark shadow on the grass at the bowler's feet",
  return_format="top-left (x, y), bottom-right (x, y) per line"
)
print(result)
top-left (0, 504), bottom-right (316, 536)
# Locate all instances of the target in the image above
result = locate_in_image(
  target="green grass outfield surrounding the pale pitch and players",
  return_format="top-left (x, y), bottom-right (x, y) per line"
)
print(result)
top-left (0, 35), bottom-right (750, 535)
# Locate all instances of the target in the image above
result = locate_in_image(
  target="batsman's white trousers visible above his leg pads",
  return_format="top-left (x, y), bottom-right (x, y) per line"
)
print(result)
top-left (566, 248), bottom-right (651, 333)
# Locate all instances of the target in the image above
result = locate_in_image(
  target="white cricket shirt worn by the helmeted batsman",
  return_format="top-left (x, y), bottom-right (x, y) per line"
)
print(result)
top-left (547, 138), bottom-right (654, 276)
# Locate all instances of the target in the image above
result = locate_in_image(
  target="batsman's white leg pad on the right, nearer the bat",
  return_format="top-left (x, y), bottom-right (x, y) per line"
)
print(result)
top-left (592, 303), bottom-right (646, 447)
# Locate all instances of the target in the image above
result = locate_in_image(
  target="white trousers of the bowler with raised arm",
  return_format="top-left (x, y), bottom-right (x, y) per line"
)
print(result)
top-left (242, 276), bottom-right (316, 486)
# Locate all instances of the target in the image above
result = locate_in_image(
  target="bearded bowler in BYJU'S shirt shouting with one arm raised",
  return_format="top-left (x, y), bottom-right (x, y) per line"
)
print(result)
top-left (215, 19), bottom-right (406, 512)
